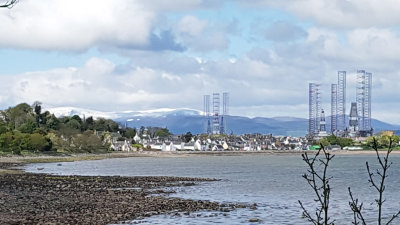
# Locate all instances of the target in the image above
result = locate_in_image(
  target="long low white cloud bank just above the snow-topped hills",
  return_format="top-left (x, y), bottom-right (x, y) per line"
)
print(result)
top-left (0, 55), bottom-right (306, 116)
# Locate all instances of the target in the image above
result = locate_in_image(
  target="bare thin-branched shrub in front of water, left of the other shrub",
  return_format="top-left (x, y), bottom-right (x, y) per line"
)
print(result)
top-left (299, 145), bottom-right (335, 225)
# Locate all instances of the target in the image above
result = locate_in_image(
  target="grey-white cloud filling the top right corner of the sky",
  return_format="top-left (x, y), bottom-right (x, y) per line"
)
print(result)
top-left (241, 0), bottom-right (400, 28)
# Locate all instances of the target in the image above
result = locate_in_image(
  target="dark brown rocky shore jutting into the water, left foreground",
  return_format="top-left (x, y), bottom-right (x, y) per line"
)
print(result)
top-left (0, 163), bottom-right (237, 224)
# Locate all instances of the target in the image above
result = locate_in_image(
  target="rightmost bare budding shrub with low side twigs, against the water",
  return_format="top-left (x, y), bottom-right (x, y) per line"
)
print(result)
top-left (348, 138), bottom-right (400, 225)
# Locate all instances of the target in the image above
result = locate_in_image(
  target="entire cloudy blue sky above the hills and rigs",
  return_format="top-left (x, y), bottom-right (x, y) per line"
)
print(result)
top-left (0, 0), bottom-right (400, 124)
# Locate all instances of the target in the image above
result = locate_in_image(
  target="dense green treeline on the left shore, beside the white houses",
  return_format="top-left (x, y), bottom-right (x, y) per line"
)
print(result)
top-left (0, 102), bottom-right (131, 154)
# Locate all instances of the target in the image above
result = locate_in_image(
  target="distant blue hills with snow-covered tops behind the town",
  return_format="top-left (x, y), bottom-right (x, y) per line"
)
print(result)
top-left (48, 107), bottom-right (400, 136)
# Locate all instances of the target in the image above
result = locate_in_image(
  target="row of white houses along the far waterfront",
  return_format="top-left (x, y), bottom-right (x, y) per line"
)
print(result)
top-left (104, 131), bottom-right (310, 151)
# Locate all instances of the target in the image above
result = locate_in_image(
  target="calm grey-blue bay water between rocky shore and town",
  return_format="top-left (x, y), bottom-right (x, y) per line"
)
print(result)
top-left (26, 154), bottom-right (400, 224)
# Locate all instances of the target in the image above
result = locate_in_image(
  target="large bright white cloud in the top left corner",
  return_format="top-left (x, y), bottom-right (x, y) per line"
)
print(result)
top-left (0, 0), bottom-right (216, 51)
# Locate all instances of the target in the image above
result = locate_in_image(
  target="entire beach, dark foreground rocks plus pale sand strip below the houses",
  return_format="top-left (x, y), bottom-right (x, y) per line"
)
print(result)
top-left (0, 150), bottom-right (400, 224)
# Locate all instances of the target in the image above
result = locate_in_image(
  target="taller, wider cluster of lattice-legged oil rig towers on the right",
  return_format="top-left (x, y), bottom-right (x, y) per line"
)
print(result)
top-left (308, 70), bottom-right (373, 139)
